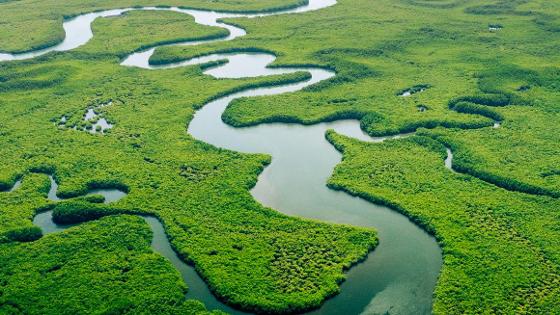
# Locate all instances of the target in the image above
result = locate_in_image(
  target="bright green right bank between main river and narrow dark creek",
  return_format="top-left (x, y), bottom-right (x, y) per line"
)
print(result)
top-left (328, 132), bottom-right (560, 314)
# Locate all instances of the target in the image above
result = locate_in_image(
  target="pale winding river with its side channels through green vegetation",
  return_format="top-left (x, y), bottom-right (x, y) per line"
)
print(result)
top-left (0, 0), bottom-right (444, 314)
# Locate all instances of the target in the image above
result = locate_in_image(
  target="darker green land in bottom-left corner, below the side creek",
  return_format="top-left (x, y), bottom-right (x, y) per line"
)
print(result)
top-left (0, 216), bottom-right (219, 314)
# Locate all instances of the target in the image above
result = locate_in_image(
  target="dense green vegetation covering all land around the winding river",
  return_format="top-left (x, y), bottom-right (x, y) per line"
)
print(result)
top-left (0, 0), bottom-right (560, 314)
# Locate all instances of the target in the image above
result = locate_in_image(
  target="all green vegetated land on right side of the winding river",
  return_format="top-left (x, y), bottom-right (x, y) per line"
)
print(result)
top-left (153, 0), bottom-right (560, 314)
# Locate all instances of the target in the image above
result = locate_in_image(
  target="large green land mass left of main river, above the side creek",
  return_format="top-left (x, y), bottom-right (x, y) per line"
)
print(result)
top-left (0, 6), bottom-right (377, 313)
